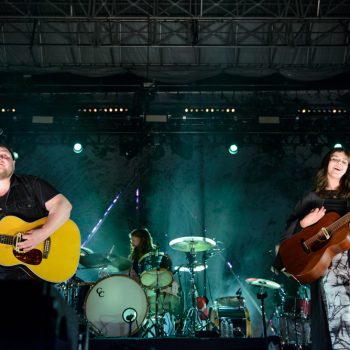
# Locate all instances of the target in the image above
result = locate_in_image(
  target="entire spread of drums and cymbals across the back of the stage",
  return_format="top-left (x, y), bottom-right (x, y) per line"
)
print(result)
top-left (58, 236), bottom-right (310, 344)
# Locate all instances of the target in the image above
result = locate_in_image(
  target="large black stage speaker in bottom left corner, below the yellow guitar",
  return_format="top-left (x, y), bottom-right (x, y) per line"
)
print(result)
top-left (0, 280), bottom-right (78, 350)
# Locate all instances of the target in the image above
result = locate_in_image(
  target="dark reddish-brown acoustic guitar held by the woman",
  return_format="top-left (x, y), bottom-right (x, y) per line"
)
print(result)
top-left (278, 212), bottom-right (350, 283)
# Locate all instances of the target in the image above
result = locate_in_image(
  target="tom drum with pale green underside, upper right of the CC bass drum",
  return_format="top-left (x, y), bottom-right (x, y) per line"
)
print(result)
top-left (138, 252), bottom-right (173, 288)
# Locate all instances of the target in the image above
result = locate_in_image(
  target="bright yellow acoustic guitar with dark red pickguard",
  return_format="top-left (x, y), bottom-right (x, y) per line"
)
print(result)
top-left (0, 216), bottom-right (80, 283)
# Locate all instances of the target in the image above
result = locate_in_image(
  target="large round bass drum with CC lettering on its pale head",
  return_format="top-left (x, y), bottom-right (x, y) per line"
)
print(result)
top-left (84, 275), bottom-right (147, 337)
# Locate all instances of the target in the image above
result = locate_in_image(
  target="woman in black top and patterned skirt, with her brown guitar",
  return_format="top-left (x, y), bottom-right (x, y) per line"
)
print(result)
top-left (275, 148), bottom-right (350, 350)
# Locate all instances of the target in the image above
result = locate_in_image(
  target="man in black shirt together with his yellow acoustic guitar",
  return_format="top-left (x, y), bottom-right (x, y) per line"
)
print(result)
top-left (0, 143), bottom-right (80, 282)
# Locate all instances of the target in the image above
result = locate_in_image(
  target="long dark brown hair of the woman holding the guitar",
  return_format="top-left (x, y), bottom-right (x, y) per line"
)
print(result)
top-left (315, 147), bottom-right (350, 197)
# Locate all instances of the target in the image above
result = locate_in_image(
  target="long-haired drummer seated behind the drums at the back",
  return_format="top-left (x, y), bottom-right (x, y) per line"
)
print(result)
top-left (129, 228), bottom-right (172, 283)
